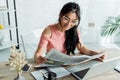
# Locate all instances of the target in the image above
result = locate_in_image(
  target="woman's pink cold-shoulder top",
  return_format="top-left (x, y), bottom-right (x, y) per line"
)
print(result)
top-left (39, 24), bottom-right (80, 54)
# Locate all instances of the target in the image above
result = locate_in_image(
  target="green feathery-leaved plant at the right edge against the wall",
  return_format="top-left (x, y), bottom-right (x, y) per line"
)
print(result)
top-left (101, 15), bottom-right (120, 37)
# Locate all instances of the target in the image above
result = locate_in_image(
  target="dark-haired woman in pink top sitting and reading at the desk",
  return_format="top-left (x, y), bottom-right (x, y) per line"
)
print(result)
top-left (34, 2), bottom-right (105, 64)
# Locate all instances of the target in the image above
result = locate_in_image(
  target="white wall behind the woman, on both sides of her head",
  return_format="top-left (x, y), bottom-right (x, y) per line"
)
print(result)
top-left (16, 0), bottom-right (120, 42)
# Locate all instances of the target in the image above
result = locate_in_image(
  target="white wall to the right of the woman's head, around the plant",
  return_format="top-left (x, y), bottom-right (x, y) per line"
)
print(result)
top-left (79, 0), bottom-right (120, 43)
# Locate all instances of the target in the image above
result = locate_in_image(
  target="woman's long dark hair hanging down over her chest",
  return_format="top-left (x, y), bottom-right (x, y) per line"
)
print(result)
top-left (59, 2), bottom-right (81, 55)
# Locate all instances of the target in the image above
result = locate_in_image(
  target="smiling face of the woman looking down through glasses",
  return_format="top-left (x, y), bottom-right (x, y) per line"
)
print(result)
top-left (60, 12), bottom-right (78, 30)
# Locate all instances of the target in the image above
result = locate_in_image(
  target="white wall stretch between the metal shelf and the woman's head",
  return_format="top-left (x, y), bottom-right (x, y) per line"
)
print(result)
top-left (16, 0), bottom-right (73, 32)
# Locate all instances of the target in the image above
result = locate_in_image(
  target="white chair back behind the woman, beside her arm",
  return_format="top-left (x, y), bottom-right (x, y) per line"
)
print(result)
top-left (20, 28), bottom-right (43, 59)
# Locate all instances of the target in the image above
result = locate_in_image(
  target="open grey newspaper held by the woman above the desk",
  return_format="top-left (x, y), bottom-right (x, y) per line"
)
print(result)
top-left (46, 49), bottom-right (104, 65)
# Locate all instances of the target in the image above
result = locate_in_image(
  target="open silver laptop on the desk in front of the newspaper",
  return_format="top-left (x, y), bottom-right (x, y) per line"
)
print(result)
top-left (67, 57), bottom-right (120, 80)
